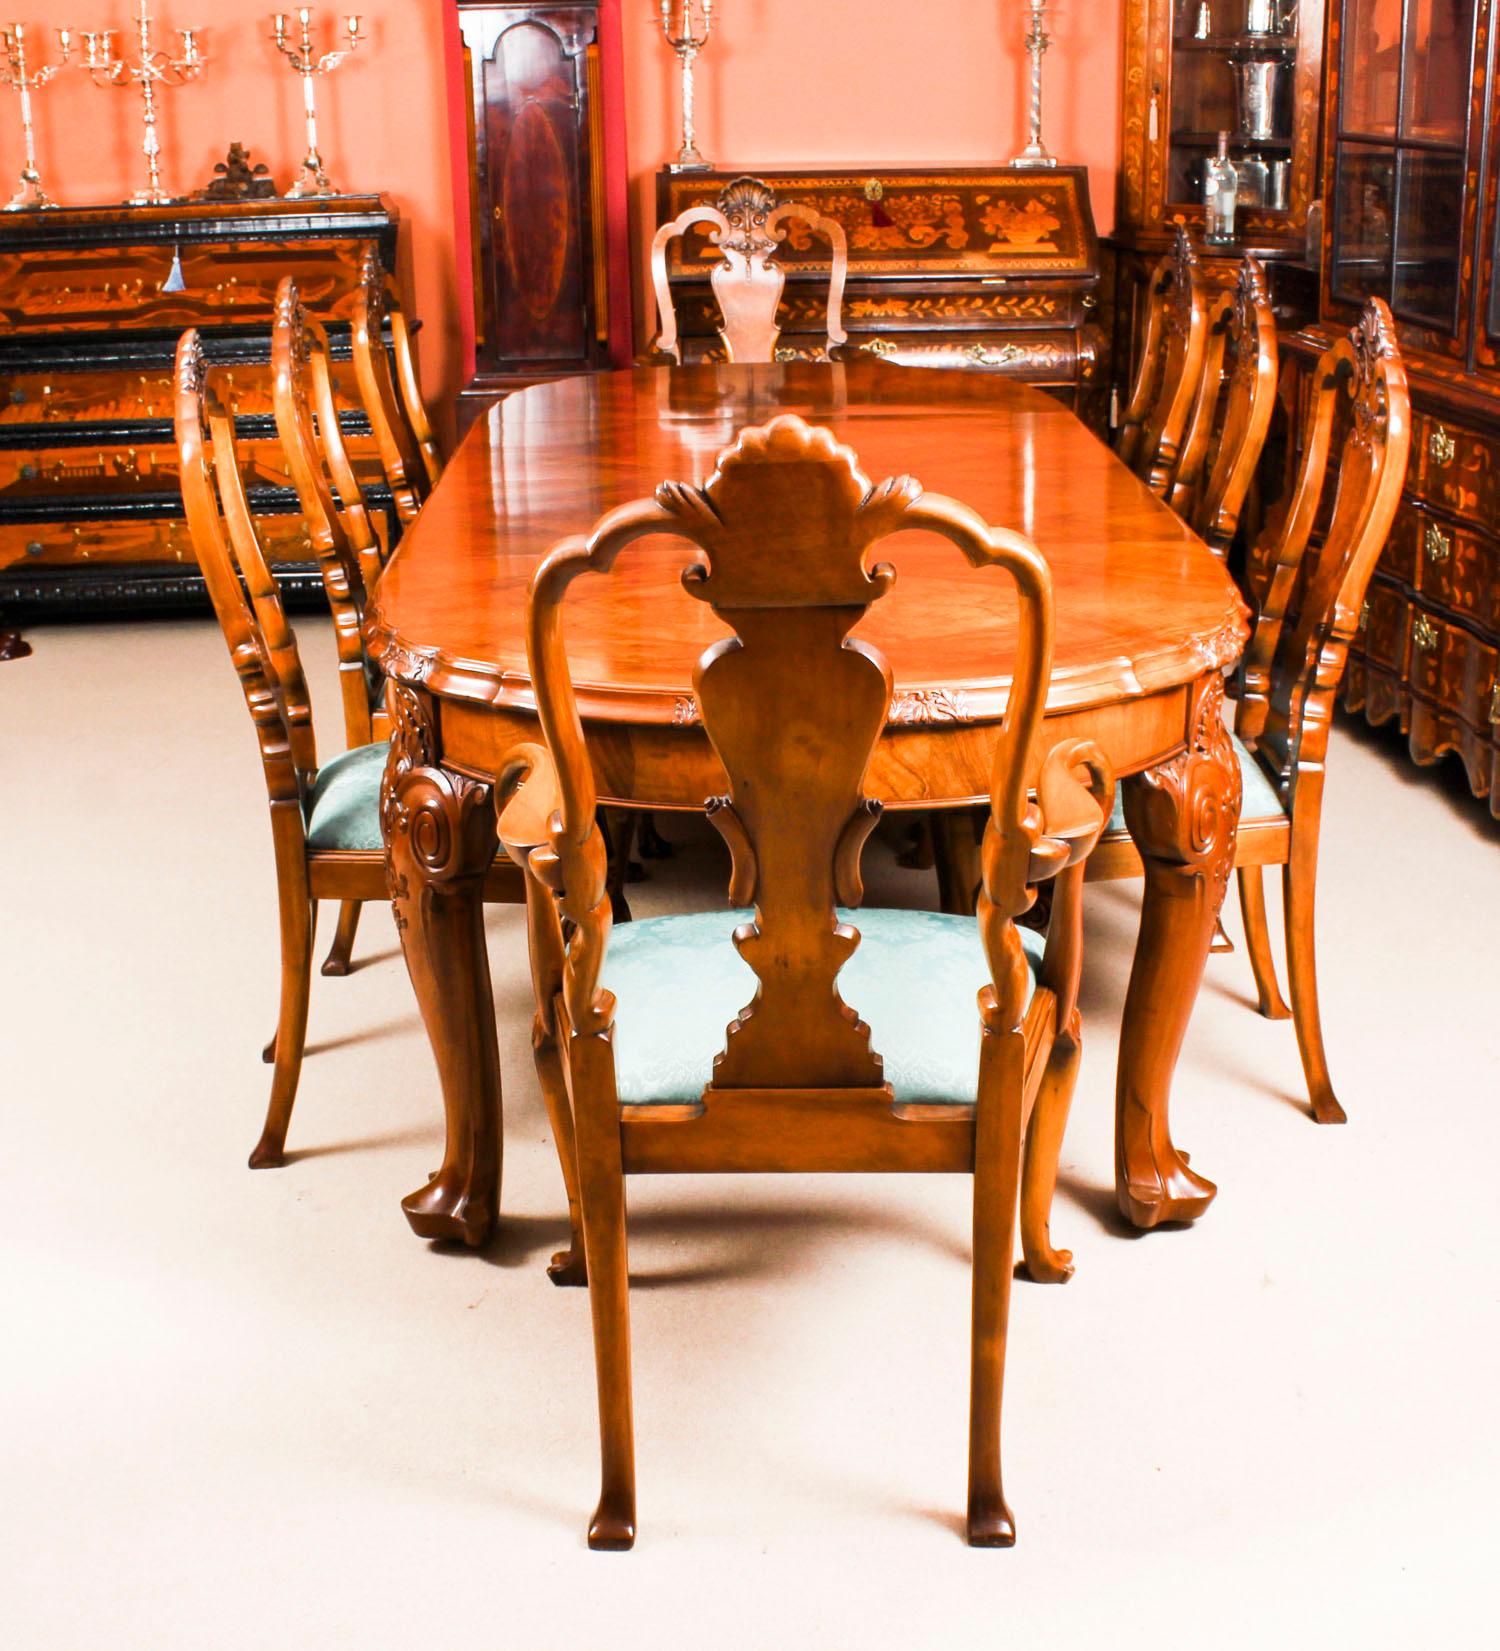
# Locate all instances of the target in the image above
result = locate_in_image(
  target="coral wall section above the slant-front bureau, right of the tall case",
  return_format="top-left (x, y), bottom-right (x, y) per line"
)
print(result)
top-left (625, 0), bottom-right (1124, 324)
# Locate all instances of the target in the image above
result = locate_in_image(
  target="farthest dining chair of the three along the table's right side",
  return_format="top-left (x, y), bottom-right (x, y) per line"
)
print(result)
top-left (1116, 225), bottom-right (1208, 499)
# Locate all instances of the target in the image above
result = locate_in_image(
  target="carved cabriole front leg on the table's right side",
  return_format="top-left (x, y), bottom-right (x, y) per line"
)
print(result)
top-left (1116, 670), bottom-right (1241, 1227)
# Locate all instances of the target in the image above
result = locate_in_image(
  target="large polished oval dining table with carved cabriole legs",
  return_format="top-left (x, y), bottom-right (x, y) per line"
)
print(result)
top-left (366, 360), bottom-right (1248, 1245)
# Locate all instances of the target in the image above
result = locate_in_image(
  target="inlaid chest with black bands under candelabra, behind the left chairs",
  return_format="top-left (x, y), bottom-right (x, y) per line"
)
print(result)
top-left (0, 195), bottom-right (399, 614)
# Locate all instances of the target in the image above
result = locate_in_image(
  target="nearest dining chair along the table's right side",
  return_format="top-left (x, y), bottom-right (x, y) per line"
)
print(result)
top-left (1087, 299), bottom-right (1411, 1124)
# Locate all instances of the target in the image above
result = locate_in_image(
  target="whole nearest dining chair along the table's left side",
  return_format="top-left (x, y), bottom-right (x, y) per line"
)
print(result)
top-left (175, 329), bottom-right (525, 1169)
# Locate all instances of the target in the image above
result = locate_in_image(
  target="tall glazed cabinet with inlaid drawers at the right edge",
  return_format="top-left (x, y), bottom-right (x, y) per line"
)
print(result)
top-left (1320, 0), bottom-right (1500, 816)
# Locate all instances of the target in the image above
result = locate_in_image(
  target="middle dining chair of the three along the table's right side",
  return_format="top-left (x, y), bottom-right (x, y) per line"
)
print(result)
top-left (1167, 253), bottom-right (1277, 541)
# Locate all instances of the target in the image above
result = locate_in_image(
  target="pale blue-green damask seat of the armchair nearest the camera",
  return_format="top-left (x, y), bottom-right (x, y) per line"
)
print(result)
top-left (599, 908), bottom-right (1045, 1106)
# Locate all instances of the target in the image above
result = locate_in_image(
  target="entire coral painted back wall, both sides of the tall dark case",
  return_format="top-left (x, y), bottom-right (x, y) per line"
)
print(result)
top-left (23, 0), bottom-right (1120, 419)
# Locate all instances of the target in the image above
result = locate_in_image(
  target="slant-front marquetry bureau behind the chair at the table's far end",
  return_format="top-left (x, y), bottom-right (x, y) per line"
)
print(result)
top-left (657, 167), bottom-right (1101, 413)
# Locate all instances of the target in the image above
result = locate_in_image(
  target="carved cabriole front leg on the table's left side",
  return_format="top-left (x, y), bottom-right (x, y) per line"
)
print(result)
top-left (380, 684), bottom-right (500, 1247)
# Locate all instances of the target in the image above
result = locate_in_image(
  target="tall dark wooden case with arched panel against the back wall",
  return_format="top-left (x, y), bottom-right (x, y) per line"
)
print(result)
top-left (459, 5), bottom-right (599, 375)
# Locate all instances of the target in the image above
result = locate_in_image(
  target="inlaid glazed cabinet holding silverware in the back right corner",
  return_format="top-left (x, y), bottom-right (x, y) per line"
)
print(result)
top-left (1116, 0), bottom-right (1320, 256)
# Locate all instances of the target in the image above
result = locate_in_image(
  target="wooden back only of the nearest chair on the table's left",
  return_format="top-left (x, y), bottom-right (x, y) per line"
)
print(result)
top-left (175, 329), bottom-right (318, 809)
